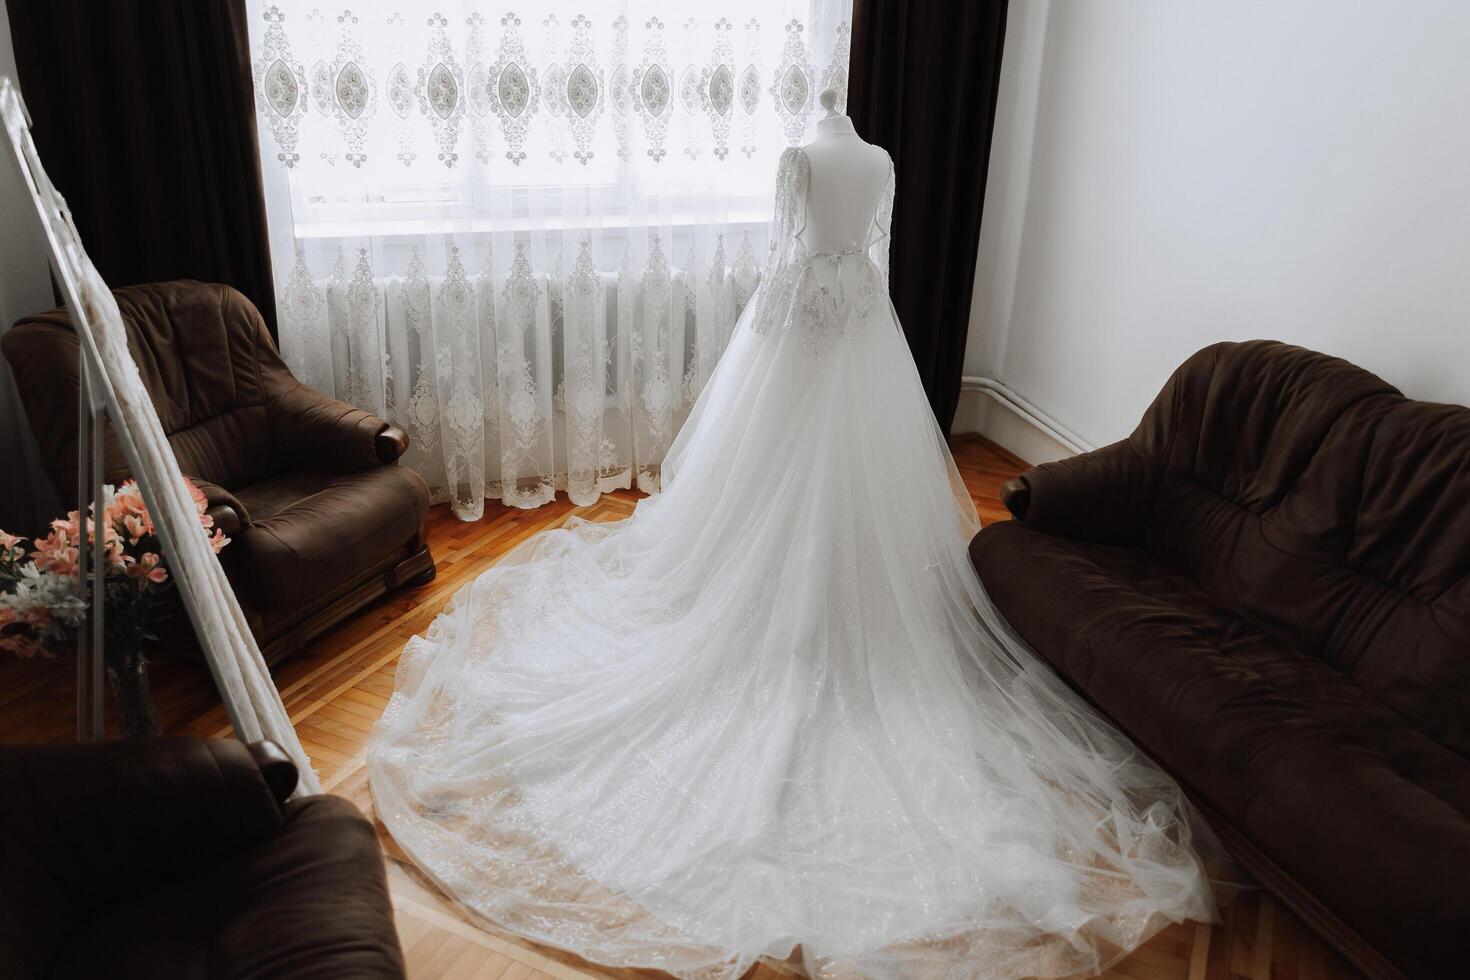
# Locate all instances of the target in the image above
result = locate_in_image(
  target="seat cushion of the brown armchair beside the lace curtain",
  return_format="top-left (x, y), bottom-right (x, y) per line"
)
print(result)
top-left (229, 466), bottom-right (429, 614)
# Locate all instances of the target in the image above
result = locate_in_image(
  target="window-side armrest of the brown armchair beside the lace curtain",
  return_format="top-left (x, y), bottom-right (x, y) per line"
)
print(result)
top-left (270, 385), bottom-right (409, 473)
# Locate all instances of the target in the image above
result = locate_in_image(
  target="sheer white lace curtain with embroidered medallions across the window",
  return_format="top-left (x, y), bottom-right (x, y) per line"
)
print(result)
top-left (250, 0), bottom-right (851, 520)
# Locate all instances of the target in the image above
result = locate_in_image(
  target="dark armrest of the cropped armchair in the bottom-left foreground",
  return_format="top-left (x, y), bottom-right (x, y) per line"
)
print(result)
top-left (0, 738), bottom-right (285, 917)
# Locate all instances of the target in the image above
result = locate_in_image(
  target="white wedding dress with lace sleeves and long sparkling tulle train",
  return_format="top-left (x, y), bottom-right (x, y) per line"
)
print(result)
top-left (370, 141), bottom-right (1214, 977)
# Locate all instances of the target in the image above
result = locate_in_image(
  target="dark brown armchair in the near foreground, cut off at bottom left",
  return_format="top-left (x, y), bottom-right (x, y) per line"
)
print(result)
top-left (0, 738), bottom-right (404, 980)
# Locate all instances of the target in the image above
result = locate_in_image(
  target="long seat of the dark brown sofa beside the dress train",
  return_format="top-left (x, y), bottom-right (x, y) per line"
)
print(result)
top-left (970, 523), bottom-right (1470, 970)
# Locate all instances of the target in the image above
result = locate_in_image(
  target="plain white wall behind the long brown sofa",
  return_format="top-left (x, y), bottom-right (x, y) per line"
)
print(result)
top-left (957, 0), bottom-right (1470, 458)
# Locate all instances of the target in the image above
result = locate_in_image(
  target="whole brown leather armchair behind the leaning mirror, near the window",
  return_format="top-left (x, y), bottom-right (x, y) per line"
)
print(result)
top-left (0, 279), bottom-right (434, 661)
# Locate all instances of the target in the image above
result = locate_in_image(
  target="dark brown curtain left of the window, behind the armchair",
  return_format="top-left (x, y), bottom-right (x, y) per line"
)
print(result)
top-left (7, 0), bottom-right (275, 335)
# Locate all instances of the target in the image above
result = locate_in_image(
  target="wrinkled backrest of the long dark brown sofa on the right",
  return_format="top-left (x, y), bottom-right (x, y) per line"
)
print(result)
top-left (1130, 341), bottom-right (1470, 754)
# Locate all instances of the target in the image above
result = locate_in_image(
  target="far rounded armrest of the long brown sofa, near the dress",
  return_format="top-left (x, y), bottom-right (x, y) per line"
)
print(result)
top-left (1001, 441), bottom-right (1158, 544)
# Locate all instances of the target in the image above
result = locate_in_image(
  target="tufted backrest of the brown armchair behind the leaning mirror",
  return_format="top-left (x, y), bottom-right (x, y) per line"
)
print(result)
top-left (0, 279), bottom-right (295, 505)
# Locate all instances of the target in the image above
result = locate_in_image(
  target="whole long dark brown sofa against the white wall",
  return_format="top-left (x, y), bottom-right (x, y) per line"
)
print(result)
top-left (970, 341), bottom-right (1470, 977)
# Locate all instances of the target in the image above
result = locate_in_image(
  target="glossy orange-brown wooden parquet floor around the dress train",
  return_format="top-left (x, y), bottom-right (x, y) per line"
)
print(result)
top-left (0, 439), bottom-right (1358, 980)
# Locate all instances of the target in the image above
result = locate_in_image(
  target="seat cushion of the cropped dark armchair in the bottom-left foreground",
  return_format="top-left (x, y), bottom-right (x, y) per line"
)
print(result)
top-left (49, 796), bottom-right (404, 980)
